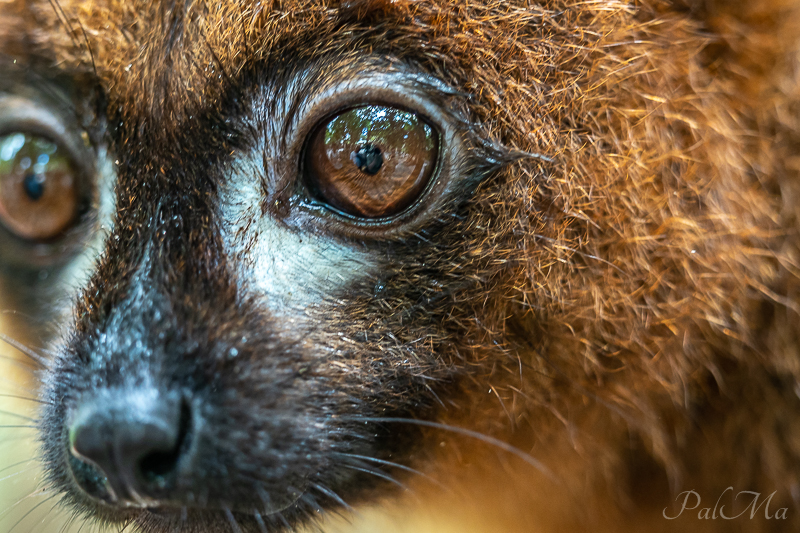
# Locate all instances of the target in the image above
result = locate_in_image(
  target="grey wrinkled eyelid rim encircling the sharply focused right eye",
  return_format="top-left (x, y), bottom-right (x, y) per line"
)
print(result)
top-left (263, 65), bottom-right (469, 234)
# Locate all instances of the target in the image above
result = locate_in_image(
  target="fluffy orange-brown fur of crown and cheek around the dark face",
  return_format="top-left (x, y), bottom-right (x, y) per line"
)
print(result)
top-left (0, 0), bottom-right (800, 532)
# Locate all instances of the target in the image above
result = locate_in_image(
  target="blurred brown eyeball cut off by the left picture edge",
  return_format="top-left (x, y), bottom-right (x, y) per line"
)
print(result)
top-left (0, 132), bottom-right (79, 241)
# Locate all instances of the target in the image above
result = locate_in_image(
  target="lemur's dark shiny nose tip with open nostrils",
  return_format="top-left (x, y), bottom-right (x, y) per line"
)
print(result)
top-left (69, 388), bottom-right (191, 505)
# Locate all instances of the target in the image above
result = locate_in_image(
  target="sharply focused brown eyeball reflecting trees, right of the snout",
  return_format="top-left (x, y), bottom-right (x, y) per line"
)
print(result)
top-left (305, 105), bottom-right (439, 218)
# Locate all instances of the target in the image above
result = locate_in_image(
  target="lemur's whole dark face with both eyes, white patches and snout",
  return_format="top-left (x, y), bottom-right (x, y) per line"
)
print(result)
top-left (0, 2), bottom-right (522, 533)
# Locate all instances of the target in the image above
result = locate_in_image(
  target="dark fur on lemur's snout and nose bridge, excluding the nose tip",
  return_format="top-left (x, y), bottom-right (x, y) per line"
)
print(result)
top-left (41, 92), bottom-right (450, 531)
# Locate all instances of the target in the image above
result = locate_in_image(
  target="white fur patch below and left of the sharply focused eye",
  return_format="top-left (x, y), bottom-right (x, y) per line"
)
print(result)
top-left (220, 160), bottom-right (377, 319)
